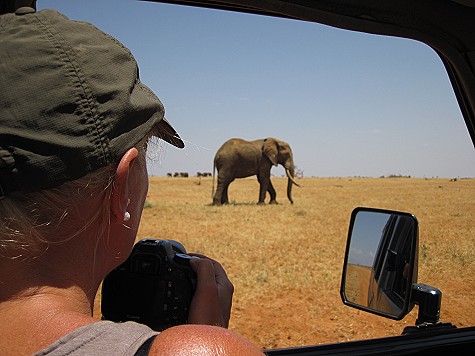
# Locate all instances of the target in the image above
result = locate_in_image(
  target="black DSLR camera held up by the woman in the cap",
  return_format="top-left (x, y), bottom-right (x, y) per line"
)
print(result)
top-left (101, 239), bottom-right (196, 331)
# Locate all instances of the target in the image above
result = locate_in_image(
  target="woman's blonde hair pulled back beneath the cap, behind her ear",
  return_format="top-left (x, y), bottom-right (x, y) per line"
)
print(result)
top-left (0, 165), bottom-right (117, 260)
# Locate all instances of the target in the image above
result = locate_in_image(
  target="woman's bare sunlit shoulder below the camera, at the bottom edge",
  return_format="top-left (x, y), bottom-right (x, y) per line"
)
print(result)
top-left (150, 325), bottom-right (263, 356)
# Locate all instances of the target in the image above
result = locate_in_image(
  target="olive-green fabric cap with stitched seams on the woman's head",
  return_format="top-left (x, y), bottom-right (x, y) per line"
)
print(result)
top-left (0, 7), bottom-right (184, 197)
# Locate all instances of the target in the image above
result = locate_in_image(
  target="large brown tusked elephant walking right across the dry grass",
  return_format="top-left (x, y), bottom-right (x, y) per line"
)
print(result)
top-left (213, 137), bottom-right (301, 205)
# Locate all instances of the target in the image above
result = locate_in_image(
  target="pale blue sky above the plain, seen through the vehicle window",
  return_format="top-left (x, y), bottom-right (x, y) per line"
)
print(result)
top-left (38, 0), bottom-right (475, 178)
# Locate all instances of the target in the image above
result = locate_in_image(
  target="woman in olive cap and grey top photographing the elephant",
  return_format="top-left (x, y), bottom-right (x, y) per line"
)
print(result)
top-left (0, 3), bottom-right (262, 355)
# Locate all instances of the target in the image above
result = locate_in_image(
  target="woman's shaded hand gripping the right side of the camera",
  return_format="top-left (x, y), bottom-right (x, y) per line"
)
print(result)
top-left (188, 254), bottom-right (234, 328)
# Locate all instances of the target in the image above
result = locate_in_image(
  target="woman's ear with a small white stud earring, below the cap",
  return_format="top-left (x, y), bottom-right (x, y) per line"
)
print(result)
top-left (111, 147), bottom-right (139, 224)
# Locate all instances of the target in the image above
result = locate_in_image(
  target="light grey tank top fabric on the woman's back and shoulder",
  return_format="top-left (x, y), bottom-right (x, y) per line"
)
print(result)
top-left (35, 321), bottom-right (158, 356)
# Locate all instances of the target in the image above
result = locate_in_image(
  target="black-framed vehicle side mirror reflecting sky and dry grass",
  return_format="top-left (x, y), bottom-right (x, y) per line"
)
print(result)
top-left (340, 208), bottom-right (419, 320)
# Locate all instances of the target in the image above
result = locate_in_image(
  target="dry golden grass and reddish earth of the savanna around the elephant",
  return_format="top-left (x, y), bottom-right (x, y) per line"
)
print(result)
top-left (96, 177), bottom-right (475, 349)
